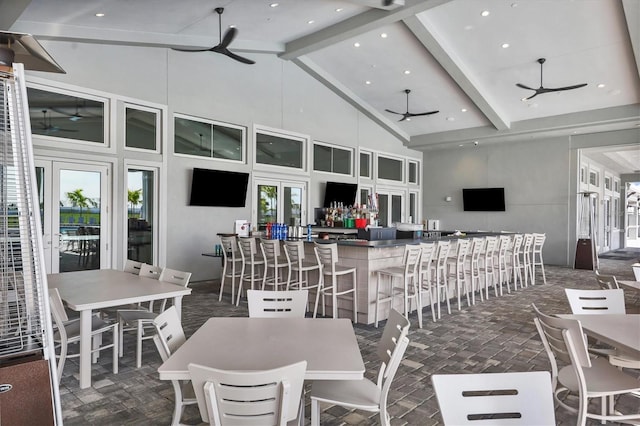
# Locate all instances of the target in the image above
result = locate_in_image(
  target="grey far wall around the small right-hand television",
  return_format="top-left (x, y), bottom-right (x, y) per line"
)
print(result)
top-left (423, 138), bottom-right (570, 265)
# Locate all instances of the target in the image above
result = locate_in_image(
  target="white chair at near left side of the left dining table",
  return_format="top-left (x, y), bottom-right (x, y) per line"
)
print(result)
top-left (49, 287), bottom-right (119, 381)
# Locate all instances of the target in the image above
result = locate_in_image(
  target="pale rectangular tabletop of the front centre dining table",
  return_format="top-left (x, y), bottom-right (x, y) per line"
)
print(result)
top-left (158, 317), bottom-right (365, 380)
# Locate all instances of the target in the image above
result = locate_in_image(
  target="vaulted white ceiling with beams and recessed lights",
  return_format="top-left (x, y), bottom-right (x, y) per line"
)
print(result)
top-left (0, 0), bottom-right (640, 172)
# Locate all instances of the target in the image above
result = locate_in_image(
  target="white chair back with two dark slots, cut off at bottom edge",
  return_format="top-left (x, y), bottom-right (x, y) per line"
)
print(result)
top-left (431, 371), bottom-right (556, 426)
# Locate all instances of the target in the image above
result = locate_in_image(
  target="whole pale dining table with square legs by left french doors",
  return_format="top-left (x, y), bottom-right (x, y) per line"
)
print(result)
top-left (47, 269), bottom-right (191, 389)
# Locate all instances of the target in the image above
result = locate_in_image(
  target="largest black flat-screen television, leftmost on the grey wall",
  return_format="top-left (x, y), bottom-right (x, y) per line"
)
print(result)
top-left (189, 168), bottom-right (249, 207)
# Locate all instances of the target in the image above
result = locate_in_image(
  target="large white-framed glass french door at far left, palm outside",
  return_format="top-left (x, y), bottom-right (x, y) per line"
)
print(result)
top-left (36, 160), bottom-right (110, 273)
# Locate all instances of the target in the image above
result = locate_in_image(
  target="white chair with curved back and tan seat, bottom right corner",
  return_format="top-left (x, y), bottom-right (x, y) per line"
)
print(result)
top-left (532, 305), bottom-right (640, 426)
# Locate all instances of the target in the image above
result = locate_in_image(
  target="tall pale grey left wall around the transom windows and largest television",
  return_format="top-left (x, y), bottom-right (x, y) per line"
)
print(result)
top-left (32, 41), bottom-right (422, 281)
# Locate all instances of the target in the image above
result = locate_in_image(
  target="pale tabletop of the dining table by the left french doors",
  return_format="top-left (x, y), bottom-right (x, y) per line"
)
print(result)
top-left (47, 269), bottom-right (191, 311)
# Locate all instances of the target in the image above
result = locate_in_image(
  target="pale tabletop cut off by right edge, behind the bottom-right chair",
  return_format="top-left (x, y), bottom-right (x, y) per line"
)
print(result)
top-left (558, 314), bottom-right (640, 357)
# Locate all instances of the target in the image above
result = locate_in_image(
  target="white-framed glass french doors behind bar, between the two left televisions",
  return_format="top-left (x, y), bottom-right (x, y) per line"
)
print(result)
top-left (253, 179), bottom-right (307, 229)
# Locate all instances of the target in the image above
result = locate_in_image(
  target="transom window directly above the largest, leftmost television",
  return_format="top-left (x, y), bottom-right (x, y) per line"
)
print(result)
top-left (174, 114), bottom-right (246, 162)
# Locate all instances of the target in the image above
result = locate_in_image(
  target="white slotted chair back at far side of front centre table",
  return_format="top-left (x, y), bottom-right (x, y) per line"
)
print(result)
top-left (247, 290), bottom-right (309, 318)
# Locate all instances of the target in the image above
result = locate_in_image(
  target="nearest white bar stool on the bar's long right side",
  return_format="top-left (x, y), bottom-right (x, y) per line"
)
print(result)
top-left (375, 245), bottom-right (422, 328)
